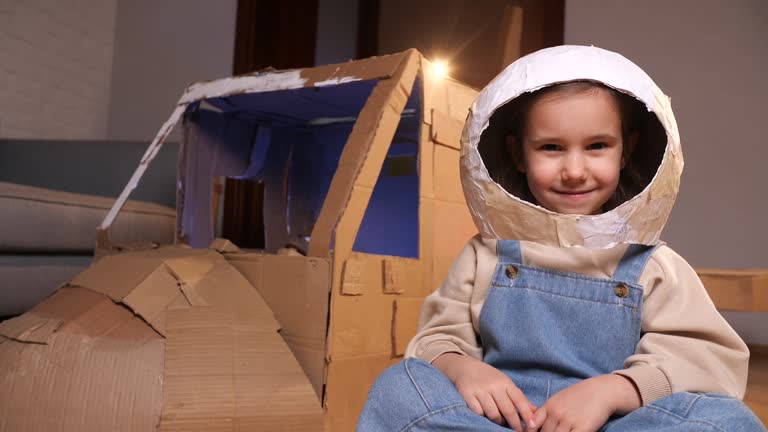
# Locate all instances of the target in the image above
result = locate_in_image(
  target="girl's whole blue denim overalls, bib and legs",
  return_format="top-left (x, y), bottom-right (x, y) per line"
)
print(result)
top-left (358, 240), bottom-right (765, 432)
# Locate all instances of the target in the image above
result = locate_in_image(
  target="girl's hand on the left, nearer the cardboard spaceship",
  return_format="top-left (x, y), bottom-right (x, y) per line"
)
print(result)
top-left (432, 353), bottom-right (536, 432)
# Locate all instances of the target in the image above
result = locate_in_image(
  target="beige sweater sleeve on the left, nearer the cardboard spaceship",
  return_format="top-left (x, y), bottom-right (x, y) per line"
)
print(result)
top-left (405, 237), bottom-right (482, 363)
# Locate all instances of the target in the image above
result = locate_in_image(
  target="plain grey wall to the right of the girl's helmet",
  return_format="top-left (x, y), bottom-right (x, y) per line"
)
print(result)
top-left (565, 0), bottom-right (768, 343)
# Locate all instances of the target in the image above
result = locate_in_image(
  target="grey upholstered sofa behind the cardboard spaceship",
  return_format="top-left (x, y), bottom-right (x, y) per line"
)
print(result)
top-left (0, 139), bottom-right (178, 317)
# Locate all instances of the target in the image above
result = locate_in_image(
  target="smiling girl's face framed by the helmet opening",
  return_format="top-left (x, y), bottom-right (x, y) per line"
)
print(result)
top-left (511, 88), bottom-right (631, 215)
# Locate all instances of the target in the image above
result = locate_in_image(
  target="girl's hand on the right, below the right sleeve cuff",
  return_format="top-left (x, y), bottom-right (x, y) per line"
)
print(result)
top-left (534, 374), bottom-right (641, 432)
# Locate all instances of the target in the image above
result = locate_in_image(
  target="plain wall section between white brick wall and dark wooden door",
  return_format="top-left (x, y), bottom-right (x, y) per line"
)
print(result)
top-left (107, 0), bottom-right (236, 140)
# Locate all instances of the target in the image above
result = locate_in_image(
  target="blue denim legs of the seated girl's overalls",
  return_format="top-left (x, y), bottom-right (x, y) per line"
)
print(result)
top-left (357, 358), bottom-right (766, 432)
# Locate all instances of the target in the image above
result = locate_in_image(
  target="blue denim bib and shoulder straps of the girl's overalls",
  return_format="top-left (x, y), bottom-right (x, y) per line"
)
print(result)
top-left (480, 241), bottom-right (654, 406)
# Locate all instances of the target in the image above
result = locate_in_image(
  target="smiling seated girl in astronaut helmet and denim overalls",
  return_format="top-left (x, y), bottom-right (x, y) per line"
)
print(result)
top-left (358, 46), bottom-right (765, 432)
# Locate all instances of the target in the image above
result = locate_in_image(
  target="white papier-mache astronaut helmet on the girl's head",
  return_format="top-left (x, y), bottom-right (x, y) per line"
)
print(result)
top-left (461, 45), bottom-right (683, 248)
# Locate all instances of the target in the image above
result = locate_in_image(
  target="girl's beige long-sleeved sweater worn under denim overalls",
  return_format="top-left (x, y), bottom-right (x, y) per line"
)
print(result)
top-left (405, 236), bottom-right (749, 405)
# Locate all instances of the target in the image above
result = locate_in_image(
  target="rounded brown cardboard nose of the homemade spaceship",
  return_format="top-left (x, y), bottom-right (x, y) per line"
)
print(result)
top-left (0, 247), bottom-right (322, 431)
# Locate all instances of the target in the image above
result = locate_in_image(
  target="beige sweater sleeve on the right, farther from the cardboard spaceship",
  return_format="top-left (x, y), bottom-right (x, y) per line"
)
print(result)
top-left (615, 246), bottom-right (749, 405)
